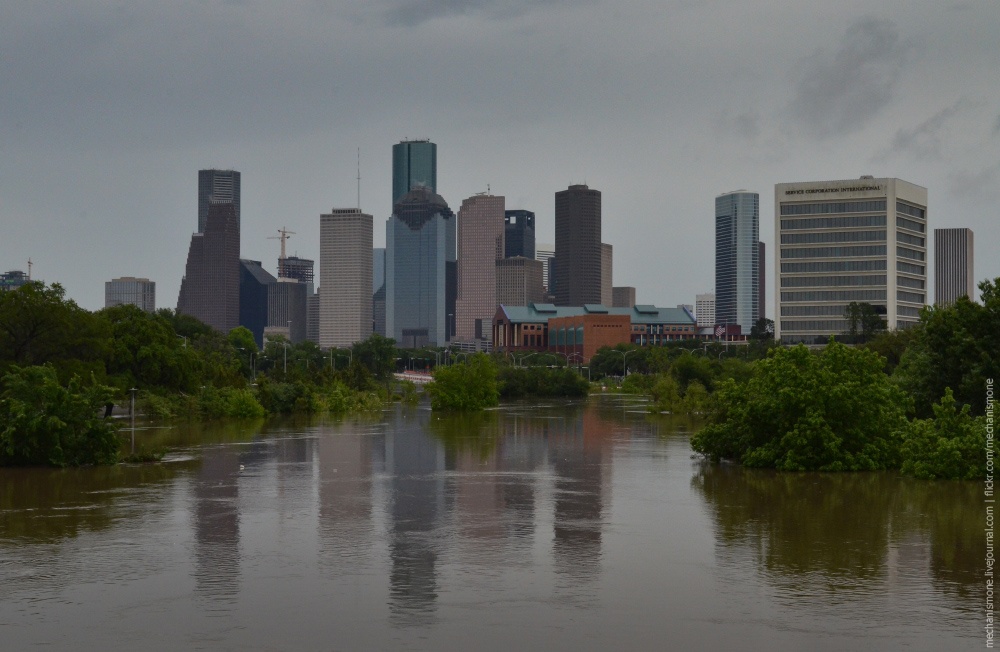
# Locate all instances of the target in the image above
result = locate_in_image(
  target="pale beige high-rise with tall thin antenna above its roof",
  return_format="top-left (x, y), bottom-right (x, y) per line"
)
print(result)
top-left (319, 208), bottom-right (374, 349)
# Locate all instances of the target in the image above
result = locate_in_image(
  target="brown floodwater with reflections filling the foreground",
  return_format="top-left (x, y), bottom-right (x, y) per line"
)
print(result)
top-left (0, 396), bottom-right (986, 652)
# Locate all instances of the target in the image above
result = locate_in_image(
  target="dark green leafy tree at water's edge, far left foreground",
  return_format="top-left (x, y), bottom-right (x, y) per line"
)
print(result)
top-left (0, 366), bottom-right (120, 466)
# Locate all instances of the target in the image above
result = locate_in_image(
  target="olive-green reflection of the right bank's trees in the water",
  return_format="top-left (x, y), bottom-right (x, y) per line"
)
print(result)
top-left (691, 464), bottom-right (982, 609)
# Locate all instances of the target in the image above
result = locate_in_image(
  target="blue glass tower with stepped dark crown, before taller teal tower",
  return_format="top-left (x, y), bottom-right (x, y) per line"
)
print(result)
top-left (386, 186), bottom-right (456, 348)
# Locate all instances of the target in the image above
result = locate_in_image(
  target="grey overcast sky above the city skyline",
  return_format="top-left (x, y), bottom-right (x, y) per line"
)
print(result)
top-left (0, 0), bottom-right (1000, 317)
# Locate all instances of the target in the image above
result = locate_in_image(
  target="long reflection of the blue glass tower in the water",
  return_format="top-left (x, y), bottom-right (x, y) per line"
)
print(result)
top-left (385, 410), bottom-right (445, 625)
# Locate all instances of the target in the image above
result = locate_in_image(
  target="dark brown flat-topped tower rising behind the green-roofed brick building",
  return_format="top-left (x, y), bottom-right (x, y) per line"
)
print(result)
top-left (549, 185), bottom-right (602, 306)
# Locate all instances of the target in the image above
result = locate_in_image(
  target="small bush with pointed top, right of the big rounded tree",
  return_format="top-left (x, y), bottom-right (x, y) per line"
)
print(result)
top-left (901, 388), bottom-right (986, 480)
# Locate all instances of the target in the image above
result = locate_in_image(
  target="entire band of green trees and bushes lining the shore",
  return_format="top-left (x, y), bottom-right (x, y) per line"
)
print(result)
top-left (0, 279), bottom-right (1000, 479)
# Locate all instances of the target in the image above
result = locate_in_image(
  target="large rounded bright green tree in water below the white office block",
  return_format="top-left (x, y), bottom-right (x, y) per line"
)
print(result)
top-left (692, 340), bottom-right (908, 471)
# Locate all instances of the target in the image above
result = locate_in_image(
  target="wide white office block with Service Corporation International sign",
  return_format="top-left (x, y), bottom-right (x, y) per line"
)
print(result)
top-left (774, 176), bottom-right (927, 343)
